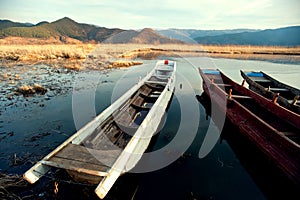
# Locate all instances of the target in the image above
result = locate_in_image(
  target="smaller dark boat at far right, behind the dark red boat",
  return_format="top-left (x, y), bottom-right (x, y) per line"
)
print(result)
top-left (241, 71), bottom-right (300, 114)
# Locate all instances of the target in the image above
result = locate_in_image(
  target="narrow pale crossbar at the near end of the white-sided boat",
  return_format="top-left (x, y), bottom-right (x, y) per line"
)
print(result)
top-left (41, 157), bottom-right (109, 176)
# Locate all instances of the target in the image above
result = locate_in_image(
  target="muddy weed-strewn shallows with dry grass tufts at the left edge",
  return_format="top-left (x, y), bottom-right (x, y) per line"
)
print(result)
top-left (0, 64), bottom-right (78, 104)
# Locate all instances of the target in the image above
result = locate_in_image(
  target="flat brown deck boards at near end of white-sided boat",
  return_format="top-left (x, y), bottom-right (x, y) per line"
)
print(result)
top-left (50, 144), bottom-right (121, 166)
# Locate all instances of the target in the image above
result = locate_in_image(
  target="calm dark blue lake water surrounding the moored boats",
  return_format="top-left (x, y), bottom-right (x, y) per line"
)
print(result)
top-left (0, 57), bottom-right (300, 200)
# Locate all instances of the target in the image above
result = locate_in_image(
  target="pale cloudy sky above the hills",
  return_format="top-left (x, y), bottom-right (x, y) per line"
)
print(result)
top-left (0, 0), bottom-right (300, 30)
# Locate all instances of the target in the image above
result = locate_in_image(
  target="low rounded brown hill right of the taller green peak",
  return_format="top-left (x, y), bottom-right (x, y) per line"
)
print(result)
top-left (104, 28), bottom-right (184, 44)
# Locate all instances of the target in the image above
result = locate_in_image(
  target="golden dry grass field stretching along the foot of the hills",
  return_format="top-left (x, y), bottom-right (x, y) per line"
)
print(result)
top-left (0, 43), bottom-right (300, 67)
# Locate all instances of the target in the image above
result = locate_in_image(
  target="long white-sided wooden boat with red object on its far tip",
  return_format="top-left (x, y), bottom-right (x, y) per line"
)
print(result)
top-left (24, 60), bottom-right (176, 198)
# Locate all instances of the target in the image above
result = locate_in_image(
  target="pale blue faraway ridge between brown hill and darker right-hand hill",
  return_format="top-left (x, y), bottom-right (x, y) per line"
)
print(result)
top-left (156, 29), bottom-right (260, 44)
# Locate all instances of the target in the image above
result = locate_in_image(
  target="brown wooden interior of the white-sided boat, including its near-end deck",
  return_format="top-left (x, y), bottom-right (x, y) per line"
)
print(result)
top-left (41, 83), bottom-right (165, 184)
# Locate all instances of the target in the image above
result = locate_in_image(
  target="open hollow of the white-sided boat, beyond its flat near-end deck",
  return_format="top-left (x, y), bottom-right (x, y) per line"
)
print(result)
top-left (82, 83), bottom-right (164, 150)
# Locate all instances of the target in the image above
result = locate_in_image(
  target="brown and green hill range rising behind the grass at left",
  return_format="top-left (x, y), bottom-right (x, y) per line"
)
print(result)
top-left (0, 17), bottom-right (183, 44)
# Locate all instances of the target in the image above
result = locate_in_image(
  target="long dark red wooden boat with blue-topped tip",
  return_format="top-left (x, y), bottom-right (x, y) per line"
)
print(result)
top-left (199, 68), bottom-right (300, 186)
